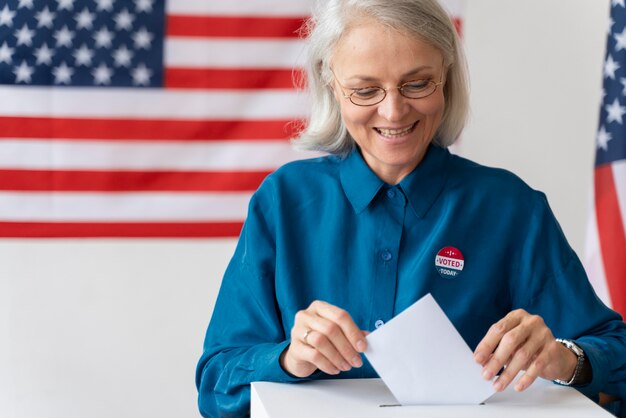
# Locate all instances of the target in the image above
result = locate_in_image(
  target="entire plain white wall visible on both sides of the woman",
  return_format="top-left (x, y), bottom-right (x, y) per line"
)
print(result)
top-left (0, 0), bottom-right (609, 418)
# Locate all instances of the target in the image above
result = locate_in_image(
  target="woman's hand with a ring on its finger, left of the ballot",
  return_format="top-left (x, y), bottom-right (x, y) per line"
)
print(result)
top-left (280, 301), bottom-right (367, 377)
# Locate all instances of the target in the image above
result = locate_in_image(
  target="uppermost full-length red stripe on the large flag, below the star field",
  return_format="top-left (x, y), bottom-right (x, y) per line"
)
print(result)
top-left (0, 117), bottom-right (299, 141)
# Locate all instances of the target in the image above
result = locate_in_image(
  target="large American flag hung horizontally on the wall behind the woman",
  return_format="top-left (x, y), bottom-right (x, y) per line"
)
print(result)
top-left (0, 0), bottom-right (462, 237)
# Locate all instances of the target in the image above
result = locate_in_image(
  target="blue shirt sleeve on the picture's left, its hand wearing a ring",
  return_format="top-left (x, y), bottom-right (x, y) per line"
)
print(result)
top-left (196, 184), bottom-right (302, 417)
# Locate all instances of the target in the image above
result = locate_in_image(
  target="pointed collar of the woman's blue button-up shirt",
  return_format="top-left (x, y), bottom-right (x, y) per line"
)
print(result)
top-left (339, 145), bottom-right (450, 218)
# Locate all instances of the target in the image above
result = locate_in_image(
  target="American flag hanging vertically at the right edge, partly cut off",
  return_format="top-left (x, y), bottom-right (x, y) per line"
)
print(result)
top-left (586, 0), bottom-right (626, 316)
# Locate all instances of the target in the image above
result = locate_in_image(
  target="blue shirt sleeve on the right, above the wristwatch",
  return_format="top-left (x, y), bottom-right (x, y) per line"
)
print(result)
top-left (517, 193), bottom-right (626, 399)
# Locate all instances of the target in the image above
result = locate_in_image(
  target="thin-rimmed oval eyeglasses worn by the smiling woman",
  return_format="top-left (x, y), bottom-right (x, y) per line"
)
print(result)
top-left (330, 66), bottom-right (443, 106)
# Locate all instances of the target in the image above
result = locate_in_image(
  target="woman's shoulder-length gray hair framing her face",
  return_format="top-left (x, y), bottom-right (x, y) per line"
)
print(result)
top-left (293, 0), bottom-right (469, 155)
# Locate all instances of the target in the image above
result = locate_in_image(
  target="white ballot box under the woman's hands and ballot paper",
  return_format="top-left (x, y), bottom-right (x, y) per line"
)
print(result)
top-left (251, 379), bottom-right (613, 418)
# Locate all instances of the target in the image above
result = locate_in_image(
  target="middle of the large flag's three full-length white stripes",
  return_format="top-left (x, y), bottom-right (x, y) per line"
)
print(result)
top-left (0, 138), bottom-right (312, 171)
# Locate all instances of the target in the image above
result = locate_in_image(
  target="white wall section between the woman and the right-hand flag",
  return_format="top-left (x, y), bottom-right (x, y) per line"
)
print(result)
top-left (460, 0), bottom-right (610, 251)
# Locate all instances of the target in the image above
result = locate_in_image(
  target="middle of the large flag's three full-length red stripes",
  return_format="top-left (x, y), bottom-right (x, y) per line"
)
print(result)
top-left (0, 170), bottom-right (269, 192)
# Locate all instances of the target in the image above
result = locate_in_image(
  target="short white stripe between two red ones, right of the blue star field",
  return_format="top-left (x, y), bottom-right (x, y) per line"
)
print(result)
top-left (164, 37), bottom-right (306, 68)
